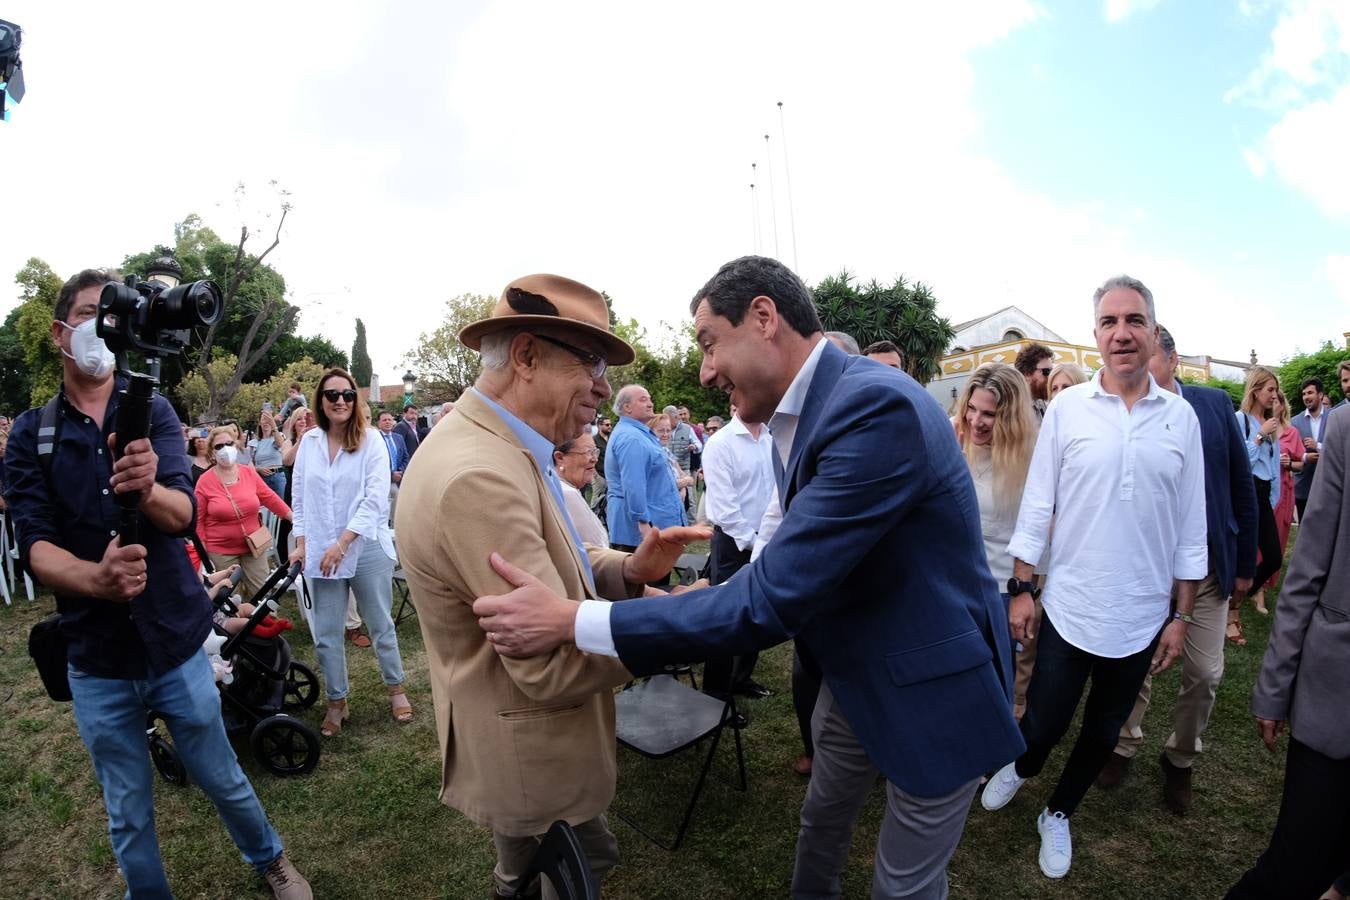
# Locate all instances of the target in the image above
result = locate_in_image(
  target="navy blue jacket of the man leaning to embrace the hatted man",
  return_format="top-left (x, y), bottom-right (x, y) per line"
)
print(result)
top-left (610, 344), bottom-right (1025, 797)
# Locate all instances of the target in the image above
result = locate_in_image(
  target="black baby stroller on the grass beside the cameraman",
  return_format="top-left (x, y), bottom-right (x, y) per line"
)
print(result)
top-left (146, 563), bottom-right (320, 784)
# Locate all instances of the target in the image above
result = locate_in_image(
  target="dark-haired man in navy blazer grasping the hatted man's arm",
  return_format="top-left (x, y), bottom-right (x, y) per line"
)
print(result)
top-left (474, 256), bottom-right (1023, 897)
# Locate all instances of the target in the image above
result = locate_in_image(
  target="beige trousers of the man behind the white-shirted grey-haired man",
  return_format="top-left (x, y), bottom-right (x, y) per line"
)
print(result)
top-left (1115, 568), bottom-right (1229, 769)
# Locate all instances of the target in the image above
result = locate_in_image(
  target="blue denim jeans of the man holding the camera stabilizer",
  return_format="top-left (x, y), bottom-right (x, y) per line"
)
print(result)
top-left (69, 650), bottom-right (282, 900)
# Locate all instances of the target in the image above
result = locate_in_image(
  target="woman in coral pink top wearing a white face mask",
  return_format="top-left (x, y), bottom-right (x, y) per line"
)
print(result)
top-left (196, 425), bottom-right (290, 596)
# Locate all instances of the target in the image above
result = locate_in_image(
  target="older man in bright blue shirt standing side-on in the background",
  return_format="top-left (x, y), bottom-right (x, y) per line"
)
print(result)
top-left (605, 385), bottom-right (689, 551)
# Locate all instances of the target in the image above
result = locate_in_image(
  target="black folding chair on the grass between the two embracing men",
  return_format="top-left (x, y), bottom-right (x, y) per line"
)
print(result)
top-left (614, 675), bottom-right (745, 850)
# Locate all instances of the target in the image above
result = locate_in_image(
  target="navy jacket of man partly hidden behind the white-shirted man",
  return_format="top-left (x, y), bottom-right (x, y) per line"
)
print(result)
top-left (1181, 385), bottom-right (1257, 596)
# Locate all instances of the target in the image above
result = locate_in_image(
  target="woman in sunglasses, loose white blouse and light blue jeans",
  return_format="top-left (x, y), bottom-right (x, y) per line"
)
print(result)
top-left (290, 368), bottom-right (413, 737)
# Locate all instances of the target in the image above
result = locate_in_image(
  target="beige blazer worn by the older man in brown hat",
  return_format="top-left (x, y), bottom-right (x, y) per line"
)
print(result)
top-left (394, 391), bottom-right (640, 837)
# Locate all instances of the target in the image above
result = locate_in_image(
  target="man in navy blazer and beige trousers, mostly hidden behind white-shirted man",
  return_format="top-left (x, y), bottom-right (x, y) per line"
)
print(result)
top-left (1096, 325), bottom-right (1257, 814)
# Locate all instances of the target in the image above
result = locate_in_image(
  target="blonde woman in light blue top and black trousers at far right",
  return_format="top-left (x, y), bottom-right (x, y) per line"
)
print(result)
top-left (1227, 366), bottom-right (1284, 644)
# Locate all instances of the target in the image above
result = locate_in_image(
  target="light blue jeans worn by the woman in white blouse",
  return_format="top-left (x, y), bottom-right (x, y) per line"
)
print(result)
top-left (306, 537), bottom-right (404, 700)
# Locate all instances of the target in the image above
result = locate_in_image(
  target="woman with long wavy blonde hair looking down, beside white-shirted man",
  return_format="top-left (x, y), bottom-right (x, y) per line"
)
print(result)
top-left (956, 363), bottom-right (1036, 696)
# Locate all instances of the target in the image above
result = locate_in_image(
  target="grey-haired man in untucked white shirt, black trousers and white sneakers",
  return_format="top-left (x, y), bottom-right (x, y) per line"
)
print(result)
top-left (981, 275), bottom-right (1207, 878)
